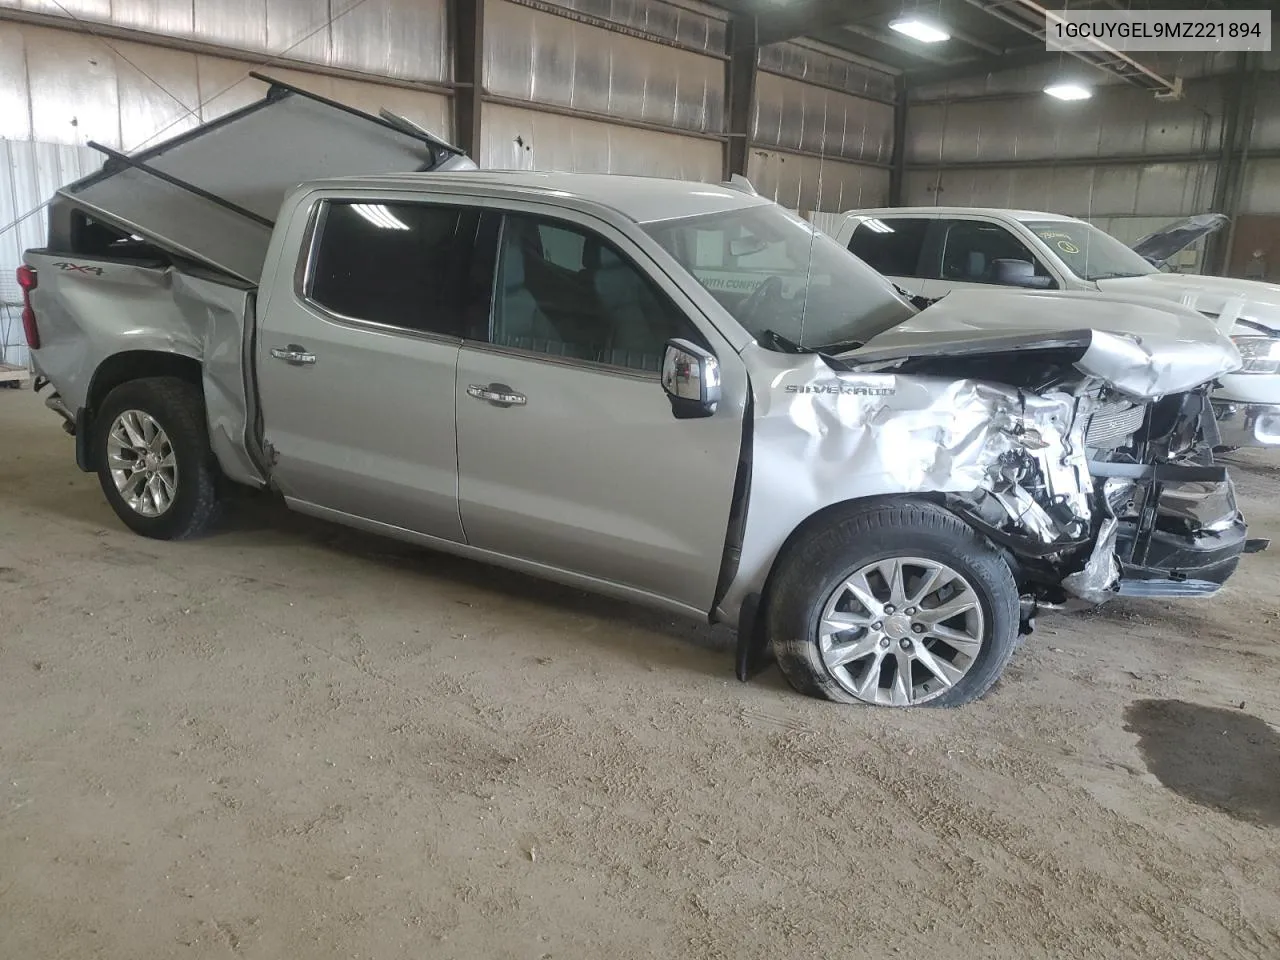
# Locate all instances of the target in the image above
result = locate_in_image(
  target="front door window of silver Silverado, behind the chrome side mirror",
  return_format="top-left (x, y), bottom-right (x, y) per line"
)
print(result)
top-left (493, 214), bottom-right (703, 372)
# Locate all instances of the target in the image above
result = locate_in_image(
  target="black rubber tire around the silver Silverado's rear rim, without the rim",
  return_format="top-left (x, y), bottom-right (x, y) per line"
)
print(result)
top-left (92, 376), bottom-right (219, 540)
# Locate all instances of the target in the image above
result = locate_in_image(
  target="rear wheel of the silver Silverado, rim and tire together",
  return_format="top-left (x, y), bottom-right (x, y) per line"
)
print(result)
top-left (92, 376), bottom-right (219, 540)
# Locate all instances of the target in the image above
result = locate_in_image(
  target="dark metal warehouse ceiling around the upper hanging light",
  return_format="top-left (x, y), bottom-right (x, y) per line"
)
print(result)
top-left (717, 0), bottom-right (1262, 95)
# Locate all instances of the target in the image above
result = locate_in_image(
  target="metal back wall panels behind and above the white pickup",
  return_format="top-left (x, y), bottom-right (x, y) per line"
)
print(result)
top-left (902, 65), bottom-right (1280, 238)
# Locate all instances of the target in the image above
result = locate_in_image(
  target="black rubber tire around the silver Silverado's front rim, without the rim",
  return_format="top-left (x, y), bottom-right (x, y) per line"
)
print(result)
top-left (768, 500), bottom-right (1019, 707)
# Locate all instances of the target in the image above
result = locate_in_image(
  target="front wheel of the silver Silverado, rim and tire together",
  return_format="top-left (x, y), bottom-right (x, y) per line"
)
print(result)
top-left (768, 502), bottom-right (1018, 707)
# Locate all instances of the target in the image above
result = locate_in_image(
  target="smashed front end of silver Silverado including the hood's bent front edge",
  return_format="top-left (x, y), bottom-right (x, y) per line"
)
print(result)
top-left (844, 316), bottom-right (1266, 617)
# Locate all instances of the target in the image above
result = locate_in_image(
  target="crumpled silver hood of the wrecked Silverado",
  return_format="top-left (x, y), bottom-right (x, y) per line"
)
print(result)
top-left (840, 288), bottom-right (1240, 399)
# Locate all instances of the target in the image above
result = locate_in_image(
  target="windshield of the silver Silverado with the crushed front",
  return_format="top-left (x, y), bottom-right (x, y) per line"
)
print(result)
top-left (645, 204), bottom-right (915, 349)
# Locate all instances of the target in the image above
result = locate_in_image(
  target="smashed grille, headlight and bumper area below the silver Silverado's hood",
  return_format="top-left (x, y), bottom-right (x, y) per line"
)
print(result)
top-left (947, 383), bottom-right (1262, 607)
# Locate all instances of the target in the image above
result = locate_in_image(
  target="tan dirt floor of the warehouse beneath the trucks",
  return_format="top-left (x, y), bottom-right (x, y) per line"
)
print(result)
top-left (0, 389), bottom-right (1280, 960)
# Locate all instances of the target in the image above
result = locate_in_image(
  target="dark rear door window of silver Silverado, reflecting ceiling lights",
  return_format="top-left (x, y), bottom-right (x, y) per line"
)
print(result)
top-left (305, 201), bottom-right (480, 337)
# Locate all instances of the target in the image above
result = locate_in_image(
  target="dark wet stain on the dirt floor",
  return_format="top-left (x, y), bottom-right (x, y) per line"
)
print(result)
top-left (1125, 700), bottom-right (1280, 827)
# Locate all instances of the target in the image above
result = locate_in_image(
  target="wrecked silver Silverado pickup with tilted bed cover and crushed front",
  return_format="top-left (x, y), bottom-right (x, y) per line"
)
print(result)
top-left (20, 78), bottom-right (1260, 707)
